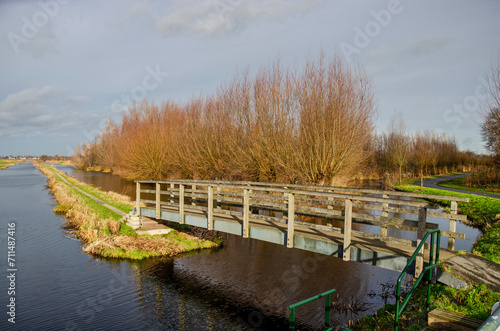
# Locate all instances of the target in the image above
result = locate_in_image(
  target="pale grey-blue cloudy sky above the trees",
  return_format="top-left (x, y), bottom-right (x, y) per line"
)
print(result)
top-left (0, 0), bottom-right (500, 156)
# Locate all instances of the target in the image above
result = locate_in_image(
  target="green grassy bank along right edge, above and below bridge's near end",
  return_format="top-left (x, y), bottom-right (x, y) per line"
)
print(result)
top-left (354, 179), bottom-right (500, 330)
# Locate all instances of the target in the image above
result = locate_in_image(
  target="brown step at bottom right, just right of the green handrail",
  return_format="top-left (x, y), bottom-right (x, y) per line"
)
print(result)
top-left (425, 308), bottom-right (484, 331)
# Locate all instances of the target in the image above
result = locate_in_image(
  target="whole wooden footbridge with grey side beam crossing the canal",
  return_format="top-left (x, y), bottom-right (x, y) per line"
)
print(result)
top-left (136, 180), bottom-right (469, 275)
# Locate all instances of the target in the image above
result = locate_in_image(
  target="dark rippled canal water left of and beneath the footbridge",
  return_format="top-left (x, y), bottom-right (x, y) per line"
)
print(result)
top-left (0, 163), bottom-right (480, 330)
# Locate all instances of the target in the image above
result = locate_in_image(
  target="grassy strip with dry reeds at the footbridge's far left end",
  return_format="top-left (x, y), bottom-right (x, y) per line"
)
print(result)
top-left (37, 164), bottom-right (221, 259)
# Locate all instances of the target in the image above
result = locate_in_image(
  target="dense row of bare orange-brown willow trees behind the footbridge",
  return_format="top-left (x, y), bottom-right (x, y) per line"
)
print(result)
top-left (74, 54), bottom-right (376, 184)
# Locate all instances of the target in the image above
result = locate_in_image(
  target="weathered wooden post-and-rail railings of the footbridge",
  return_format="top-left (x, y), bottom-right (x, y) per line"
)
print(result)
top-left (136, 180), bottom-right (468, 273)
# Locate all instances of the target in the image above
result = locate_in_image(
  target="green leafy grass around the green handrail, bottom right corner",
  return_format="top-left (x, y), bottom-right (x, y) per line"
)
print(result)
top-left (353, 284), bottom-right (500, 331)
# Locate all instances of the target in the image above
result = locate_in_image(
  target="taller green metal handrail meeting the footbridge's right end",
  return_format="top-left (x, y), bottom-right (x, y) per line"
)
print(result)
top-left (394, 229), bottom-right (441, 331)
